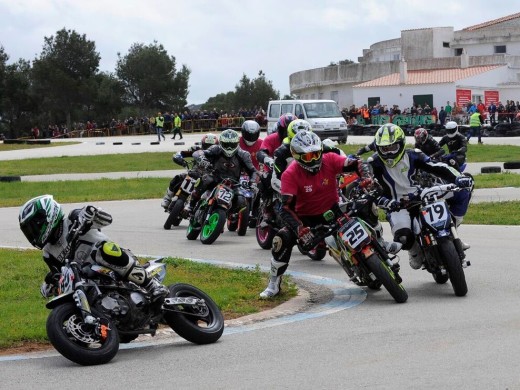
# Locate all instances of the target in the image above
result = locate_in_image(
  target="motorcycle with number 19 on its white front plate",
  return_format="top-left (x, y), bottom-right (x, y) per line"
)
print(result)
top-left (401, 184), bottom-right (471, 297)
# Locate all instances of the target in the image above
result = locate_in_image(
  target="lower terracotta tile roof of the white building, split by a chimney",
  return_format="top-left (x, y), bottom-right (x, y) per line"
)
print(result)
top-left (354, 65), bottom-right (505, 88)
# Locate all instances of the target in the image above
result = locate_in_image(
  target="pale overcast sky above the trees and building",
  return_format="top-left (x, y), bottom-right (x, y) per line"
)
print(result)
top-left (0, 0), bottom-right (520, 104)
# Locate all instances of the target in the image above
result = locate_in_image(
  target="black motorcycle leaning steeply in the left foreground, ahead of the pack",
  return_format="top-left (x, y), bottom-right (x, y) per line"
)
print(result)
top-left (46, 224), bottom-right (224, 366)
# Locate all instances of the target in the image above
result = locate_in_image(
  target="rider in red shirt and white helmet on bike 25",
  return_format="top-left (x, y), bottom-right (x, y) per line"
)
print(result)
top-left (260, 130), bottom-right (372, 298)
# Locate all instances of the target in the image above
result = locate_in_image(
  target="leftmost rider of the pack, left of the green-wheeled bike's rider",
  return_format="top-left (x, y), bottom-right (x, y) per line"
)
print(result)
top-left (161, 133), bottom-right (218, 210)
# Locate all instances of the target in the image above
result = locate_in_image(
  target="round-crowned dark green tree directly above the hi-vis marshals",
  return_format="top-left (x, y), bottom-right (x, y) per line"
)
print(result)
top-left (116, 42), bottom-right (191, 112)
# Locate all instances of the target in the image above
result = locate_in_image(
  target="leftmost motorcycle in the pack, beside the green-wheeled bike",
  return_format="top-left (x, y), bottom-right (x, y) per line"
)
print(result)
top-left (164, 159), bottom-right (200, 230)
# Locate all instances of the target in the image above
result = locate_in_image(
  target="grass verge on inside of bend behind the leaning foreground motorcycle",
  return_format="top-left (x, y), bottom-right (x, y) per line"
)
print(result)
top-left (0, 248), bottom-right (297, 350)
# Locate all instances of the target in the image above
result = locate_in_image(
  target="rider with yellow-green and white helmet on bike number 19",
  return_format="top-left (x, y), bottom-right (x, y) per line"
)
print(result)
top-left (371, 123), bottom-right (473, 269)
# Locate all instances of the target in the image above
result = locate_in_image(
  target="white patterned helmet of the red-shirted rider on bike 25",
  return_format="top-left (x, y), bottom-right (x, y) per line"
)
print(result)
top-left (290, 130), bottom-right (323, 174)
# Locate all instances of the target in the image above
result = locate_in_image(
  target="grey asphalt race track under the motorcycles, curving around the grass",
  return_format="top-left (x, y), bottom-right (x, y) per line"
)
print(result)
top-left (0, 137), bottom-right (520, 389)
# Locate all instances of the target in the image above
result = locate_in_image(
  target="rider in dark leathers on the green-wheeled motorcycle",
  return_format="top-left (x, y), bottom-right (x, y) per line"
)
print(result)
top-left (185, 129), bottom-right (258, 213)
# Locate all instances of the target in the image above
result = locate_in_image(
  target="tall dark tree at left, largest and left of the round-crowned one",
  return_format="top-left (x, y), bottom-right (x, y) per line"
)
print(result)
top-left (32, 28), bottom-right (100, 128)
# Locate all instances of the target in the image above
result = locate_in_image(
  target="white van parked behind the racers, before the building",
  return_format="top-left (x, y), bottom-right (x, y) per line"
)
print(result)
top-left (267, 100), bottom-right (348, 143)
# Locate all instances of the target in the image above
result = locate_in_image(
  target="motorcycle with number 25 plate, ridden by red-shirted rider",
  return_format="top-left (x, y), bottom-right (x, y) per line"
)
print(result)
top-left (302, 192), bottom-right (408, 303)
